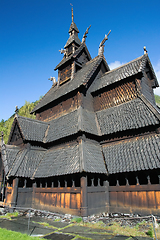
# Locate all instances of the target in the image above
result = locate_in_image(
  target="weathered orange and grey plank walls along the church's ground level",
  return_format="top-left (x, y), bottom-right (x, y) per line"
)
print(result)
top-left (6, 184), bottom-right (160, 216)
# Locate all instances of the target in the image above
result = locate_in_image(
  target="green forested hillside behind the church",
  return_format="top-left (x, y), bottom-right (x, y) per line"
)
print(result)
top-left (0, 95), bottom-right (160, 144)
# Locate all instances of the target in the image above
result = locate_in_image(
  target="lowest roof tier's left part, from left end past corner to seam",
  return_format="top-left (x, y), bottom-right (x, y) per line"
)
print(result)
top-left (2, 139), bottom-right (107, 178)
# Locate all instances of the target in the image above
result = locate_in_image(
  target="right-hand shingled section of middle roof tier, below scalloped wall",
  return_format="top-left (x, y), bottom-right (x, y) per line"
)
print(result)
top-left (96, 98), bottom-right (160, 135)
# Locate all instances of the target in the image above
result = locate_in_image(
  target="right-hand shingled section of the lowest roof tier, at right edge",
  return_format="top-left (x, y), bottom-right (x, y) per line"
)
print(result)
top-left (102, 134), bottom-right (160, 174)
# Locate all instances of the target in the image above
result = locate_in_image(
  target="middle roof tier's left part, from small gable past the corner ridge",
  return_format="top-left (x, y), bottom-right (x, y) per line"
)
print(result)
top-left (10, 106), bottom-right (100, 143)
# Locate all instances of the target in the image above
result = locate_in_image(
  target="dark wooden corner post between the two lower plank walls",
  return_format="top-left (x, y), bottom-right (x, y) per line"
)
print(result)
top-left (81, 176), bottom-right (88, 217)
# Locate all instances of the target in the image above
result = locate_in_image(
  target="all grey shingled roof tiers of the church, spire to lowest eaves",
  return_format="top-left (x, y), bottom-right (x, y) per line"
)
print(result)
top-left (2, 15), bottom-right (160, 178)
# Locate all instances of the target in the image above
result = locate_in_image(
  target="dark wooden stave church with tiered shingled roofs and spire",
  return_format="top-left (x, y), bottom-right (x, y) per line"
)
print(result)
top-left (1, 11), bottom-right (160, 216)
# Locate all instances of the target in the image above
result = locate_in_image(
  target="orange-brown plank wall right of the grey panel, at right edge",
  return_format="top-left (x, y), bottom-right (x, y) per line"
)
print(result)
top-left (109, 184), bottom-right (160, 214)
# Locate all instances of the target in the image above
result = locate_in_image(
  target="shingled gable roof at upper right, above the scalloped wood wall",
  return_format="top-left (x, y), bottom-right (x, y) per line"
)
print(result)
top-left (91, 54), bottom-right (158, 92)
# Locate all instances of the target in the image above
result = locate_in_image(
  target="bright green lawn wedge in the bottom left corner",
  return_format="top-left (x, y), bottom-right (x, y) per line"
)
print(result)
top-left (0, 228), bottom-right (42, 240)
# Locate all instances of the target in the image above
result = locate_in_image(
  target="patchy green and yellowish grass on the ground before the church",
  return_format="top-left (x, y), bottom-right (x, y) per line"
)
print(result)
top-left (0, 212), bottom-right (160, 240)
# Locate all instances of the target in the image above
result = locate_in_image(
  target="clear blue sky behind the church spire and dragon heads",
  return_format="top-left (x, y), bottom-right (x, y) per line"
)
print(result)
top-left (0, 0), bottom-right (160, 120)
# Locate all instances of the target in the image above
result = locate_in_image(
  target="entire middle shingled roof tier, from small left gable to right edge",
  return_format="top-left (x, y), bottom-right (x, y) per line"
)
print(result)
top-left (11, 95), bottom-right (160, 143)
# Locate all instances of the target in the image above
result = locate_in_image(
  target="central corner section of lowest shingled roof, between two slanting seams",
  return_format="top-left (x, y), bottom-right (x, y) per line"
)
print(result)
top-left (34, 140), bottom-right (107, 178)
